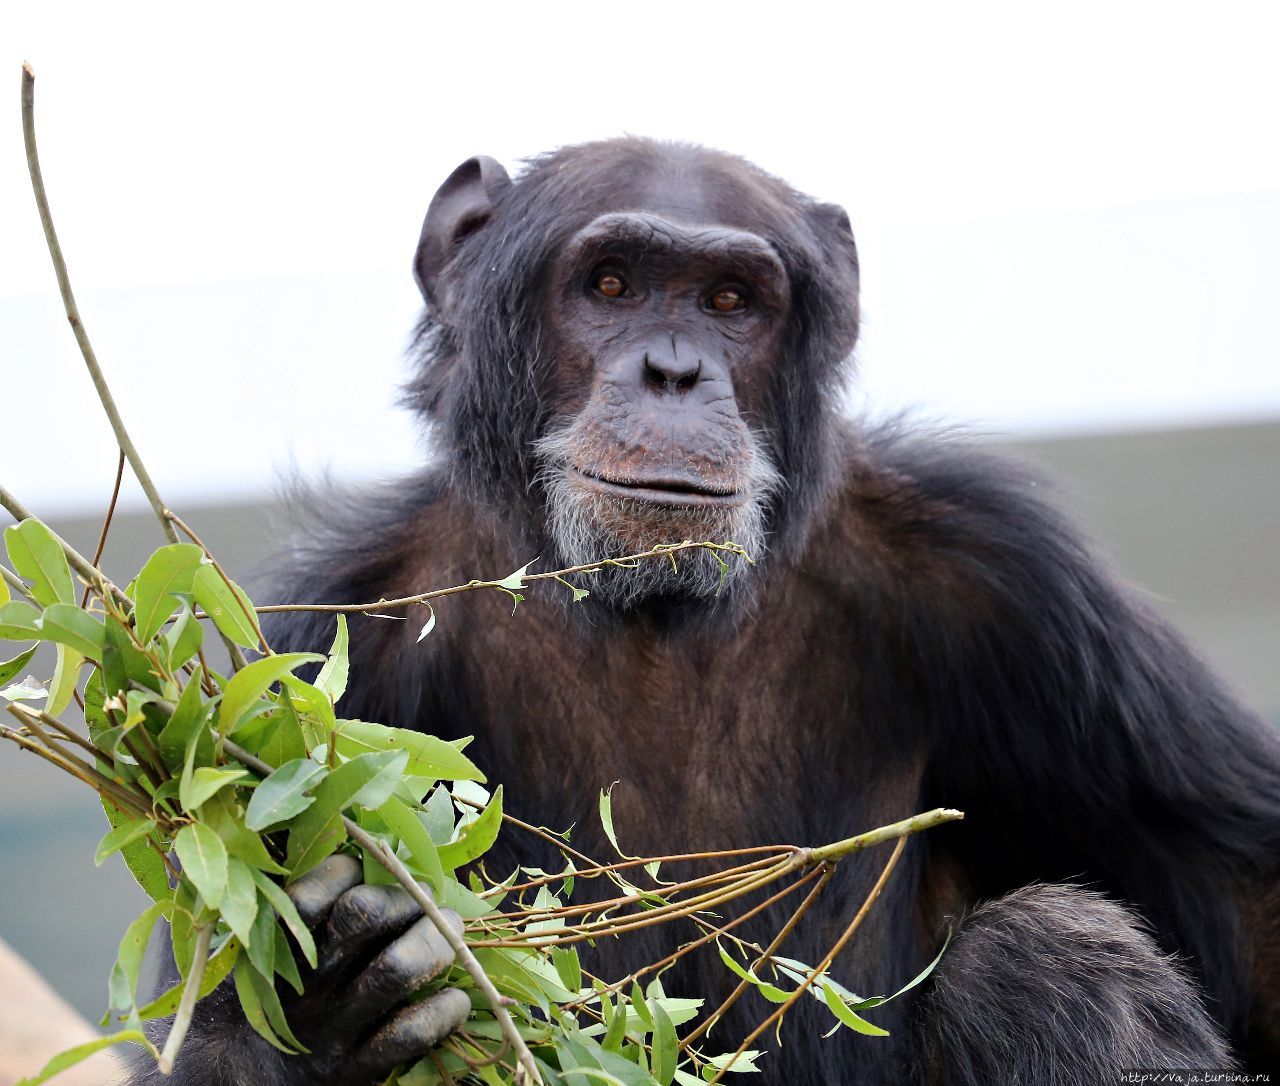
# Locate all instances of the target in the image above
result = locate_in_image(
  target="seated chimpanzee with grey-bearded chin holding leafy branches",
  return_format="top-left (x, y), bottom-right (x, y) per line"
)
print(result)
top-left (132, 138), bottom-right (1280, 1086)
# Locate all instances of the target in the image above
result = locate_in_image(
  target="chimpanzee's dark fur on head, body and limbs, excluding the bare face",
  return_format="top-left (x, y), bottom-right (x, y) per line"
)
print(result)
top-left (135, 141), bottom-right (1280, 1086)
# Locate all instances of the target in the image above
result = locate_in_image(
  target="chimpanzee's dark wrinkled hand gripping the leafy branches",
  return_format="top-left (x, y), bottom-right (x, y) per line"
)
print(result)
top-left (131, 855), bottom-right (471, 1086)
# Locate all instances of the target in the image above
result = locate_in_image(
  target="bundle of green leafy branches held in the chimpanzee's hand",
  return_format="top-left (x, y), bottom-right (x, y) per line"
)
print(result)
top-left (0, 68), bottom-right (960, 1086)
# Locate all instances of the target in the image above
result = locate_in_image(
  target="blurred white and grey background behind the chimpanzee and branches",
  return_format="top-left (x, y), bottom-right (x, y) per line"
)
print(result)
top-left (0, 0), bottom-right (1280, 1019)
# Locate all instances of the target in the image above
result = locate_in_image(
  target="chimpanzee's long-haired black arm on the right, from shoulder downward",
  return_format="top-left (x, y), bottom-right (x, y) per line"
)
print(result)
top-left (890, 435), bottom-right (1280, 1070)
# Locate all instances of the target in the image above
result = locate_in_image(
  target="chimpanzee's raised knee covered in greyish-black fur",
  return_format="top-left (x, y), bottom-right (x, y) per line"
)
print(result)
top-left (925, 885), bottom-right (1231, 1086)
